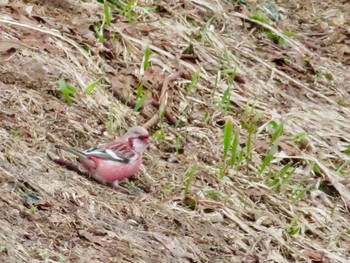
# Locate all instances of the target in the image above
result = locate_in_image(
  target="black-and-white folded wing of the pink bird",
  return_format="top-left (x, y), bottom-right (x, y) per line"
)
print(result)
top-left (84, 148), bottom-right (135, 163)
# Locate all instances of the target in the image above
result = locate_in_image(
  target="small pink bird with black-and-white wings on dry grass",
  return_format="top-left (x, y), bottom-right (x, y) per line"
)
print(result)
top-left (57, 126), bottom-right (149, 186)
